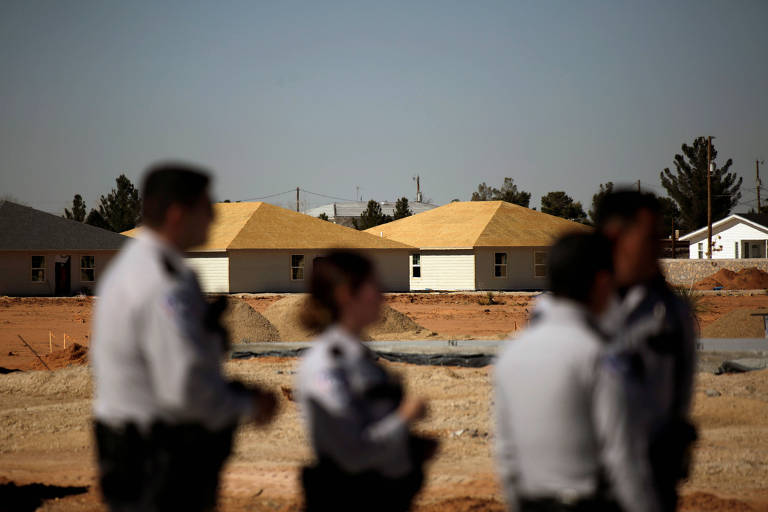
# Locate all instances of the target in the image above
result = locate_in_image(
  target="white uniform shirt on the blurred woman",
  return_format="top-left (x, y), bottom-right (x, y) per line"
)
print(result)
top-left (297, 326), bottom-right (411, 478)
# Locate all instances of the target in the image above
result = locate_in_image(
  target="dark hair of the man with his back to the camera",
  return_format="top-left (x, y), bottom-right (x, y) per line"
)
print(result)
top-left (549, 233), bottom-right (613, 304)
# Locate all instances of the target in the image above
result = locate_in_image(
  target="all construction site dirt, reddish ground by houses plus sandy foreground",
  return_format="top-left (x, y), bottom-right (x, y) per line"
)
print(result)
top-left (0, 293), bottom-right (768, 512)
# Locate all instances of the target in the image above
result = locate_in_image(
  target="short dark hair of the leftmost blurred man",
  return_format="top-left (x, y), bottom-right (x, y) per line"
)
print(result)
top-left (141, 162), bottom-right (211, 226)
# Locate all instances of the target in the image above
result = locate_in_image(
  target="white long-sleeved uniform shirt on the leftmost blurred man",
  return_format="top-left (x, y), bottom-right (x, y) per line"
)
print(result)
top-left (90, 228), bottom-right (253, 431)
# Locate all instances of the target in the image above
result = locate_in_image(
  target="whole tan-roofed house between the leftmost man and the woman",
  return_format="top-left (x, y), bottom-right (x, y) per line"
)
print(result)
top-left (125, 202), bottom-right (413, 293)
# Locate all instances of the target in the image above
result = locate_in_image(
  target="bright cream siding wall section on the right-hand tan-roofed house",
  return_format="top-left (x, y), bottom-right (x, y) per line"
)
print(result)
top-left (409, 249), bottom-right (475, 290)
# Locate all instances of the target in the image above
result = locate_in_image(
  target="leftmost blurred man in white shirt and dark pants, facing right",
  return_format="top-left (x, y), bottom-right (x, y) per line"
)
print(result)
top-left (91, 164), bottom-right (276, 511)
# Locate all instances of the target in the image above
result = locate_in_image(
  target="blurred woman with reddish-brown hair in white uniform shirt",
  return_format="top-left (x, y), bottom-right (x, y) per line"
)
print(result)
top-left (297, 252), bottom-right (436, 512)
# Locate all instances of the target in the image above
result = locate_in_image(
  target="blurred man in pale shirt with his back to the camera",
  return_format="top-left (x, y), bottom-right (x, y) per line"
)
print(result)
top-left (493, 234), bottom-right (658, 512)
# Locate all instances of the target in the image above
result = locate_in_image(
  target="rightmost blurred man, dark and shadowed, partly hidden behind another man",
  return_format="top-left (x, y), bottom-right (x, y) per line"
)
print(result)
top-left (597, 190), bottom-right (696, 511)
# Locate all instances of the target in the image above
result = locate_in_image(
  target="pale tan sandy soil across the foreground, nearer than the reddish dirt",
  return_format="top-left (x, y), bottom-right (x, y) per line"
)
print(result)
top-left (0, 359), bottom-right (768, 512)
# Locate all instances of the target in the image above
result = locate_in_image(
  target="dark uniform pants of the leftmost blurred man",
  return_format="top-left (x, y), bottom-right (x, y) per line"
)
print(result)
top-left (94, 422), bottom-right (234, 512)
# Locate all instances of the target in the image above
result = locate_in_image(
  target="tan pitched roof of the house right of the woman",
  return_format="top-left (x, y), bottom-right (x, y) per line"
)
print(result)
top-left (367, 201), bottom-right (591, 249)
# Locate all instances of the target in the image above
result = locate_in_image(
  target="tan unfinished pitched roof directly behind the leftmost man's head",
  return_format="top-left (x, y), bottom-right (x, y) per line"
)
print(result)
top-left (123, 202), bottom-right (411, 252)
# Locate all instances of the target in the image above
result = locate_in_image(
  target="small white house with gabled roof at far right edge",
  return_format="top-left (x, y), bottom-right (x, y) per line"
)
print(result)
top-left (680, 213), bottom-right (768, 259)
